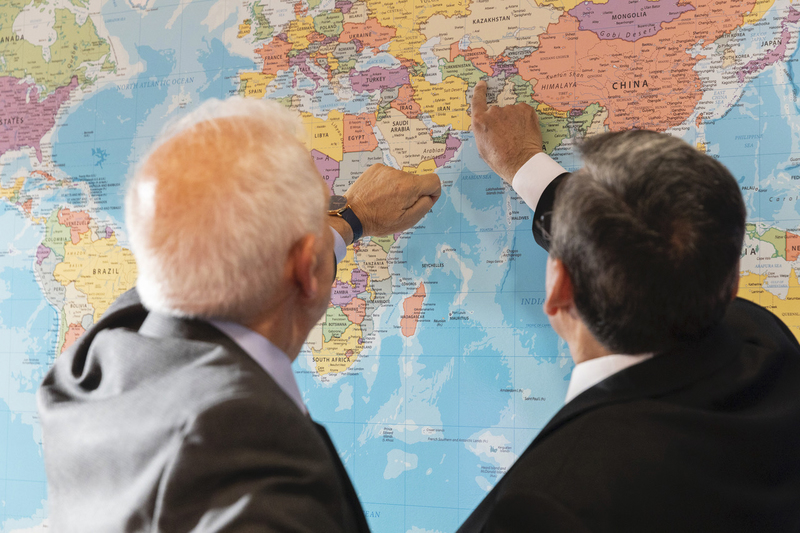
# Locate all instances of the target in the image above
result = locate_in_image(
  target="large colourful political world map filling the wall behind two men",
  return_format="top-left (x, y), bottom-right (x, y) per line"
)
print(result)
top-left (0, 0), bottom-right (800, 533)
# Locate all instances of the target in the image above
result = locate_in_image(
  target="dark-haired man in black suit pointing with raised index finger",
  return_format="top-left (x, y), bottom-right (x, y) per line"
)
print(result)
top-left (460, 84), bottom-right (800, 532)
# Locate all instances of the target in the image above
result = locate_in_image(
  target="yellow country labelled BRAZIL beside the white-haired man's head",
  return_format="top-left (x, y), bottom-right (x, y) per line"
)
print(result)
top-left (53, 231), bottom-right (137, 322)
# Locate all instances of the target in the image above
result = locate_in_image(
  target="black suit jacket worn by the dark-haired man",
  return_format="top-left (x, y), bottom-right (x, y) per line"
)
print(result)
top-left (459, 177), bottom-right (800, 533)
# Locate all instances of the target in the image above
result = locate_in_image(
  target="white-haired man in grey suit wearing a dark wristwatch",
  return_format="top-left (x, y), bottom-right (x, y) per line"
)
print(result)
top-left (39, 99), bottom-right (440, 533)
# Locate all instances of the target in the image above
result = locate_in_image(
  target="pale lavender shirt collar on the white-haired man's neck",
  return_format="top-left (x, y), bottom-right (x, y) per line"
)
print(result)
top-left (208, 320), bottom-right (308, 414)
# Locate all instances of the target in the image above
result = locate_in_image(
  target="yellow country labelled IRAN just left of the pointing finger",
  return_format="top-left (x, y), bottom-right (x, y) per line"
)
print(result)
top-left (411, 76), bottom-right (471, 131)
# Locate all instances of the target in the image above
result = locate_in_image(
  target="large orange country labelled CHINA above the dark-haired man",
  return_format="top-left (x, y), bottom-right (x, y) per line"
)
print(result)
top-left (516, 0), bottom-right (755, 131)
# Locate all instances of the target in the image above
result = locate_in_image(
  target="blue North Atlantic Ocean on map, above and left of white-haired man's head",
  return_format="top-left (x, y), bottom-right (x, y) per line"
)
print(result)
top-left (53, 3), bottom-right (253, 224)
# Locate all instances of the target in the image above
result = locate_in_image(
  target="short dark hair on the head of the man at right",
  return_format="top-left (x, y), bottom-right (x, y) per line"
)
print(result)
top-left (550, 130), bottom-right (746, 354)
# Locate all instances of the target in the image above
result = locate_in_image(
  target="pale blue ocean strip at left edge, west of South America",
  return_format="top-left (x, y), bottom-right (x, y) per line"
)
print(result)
top-left (0, 203), bottom-right (58, 529)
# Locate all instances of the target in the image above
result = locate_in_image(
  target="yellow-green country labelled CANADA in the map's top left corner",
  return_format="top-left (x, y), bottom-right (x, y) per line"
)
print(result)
top-left (0, 8), bottom-right (113, 95)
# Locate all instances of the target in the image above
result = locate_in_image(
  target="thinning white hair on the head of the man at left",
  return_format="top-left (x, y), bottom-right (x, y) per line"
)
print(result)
top-left (125, 97), bottom-right (325, 323)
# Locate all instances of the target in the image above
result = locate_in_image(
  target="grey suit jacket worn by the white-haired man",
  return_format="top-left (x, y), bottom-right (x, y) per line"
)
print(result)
top-left (38, 290), bottom-right (368, 533)
